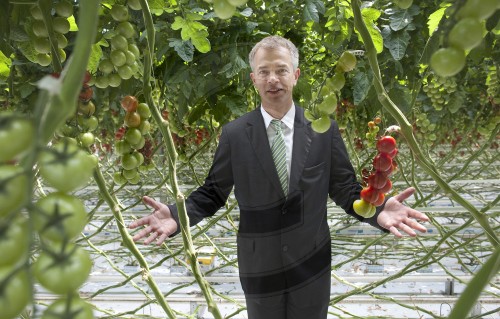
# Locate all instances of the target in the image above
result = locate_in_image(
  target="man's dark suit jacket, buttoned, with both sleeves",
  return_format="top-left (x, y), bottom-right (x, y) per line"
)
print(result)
top-left (169, 107), bottom-right (380, 297)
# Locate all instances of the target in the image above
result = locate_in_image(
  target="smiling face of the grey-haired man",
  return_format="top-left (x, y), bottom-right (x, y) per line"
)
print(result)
top-left (250, 47), bottom-right (300, 107)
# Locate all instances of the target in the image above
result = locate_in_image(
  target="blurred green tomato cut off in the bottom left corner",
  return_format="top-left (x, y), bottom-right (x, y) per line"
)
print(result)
top-left (0, 267), bottom-right (33, 319)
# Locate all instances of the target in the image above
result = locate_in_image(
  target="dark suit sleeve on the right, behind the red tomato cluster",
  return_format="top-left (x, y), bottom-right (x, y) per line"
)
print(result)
top-left (329, 121), bottom-right (387, 231)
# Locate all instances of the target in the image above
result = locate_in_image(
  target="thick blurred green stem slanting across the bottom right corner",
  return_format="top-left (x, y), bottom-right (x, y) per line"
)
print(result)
top-left (448, 246), bottom-right (500, 319)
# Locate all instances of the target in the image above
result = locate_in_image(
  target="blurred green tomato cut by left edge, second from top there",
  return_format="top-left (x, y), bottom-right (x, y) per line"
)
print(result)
top-left (0, 165), bottom-right (28, 217)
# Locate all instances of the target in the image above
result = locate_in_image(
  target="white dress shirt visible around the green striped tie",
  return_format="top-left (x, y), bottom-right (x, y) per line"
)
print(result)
top-left (260, 104), bottom-right (295, 181)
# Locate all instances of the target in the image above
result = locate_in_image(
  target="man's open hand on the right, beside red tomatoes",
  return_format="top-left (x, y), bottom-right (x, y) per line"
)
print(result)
top-left (377, 187), bottom-right (429, 237)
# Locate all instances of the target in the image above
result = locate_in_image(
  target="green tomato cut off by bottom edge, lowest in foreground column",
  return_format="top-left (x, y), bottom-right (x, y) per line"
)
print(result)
top-left (41, 294), bottom-right (95, 319)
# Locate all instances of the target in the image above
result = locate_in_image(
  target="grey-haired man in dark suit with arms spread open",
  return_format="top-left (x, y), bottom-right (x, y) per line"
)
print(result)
top-left (130, 36), bottom-right (428, 319)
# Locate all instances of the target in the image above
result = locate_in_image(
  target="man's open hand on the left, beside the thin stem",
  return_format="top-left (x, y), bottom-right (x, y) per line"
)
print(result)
top-left (128, 196), bottom-right (177, 245)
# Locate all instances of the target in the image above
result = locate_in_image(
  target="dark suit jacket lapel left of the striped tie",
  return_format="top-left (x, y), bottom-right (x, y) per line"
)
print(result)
top-left (246, 108), bottom-right (284, 196)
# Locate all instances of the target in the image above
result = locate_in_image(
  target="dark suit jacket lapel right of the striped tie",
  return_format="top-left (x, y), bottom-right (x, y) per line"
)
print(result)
top-left (289, 107), bottom-right (312, 190)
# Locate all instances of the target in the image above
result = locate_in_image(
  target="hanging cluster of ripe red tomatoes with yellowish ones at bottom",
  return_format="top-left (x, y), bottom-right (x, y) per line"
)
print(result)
top-left (353, 136), bottom-right (398, 218)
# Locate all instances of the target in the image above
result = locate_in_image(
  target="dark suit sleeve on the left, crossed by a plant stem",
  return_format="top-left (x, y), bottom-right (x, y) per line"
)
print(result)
top-left (168, 128), bottom-right (234, 236)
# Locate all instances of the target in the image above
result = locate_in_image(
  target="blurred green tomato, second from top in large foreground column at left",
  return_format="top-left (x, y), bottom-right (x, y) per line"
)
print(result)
top-left (31, 192), bottom-right (88, 242)
